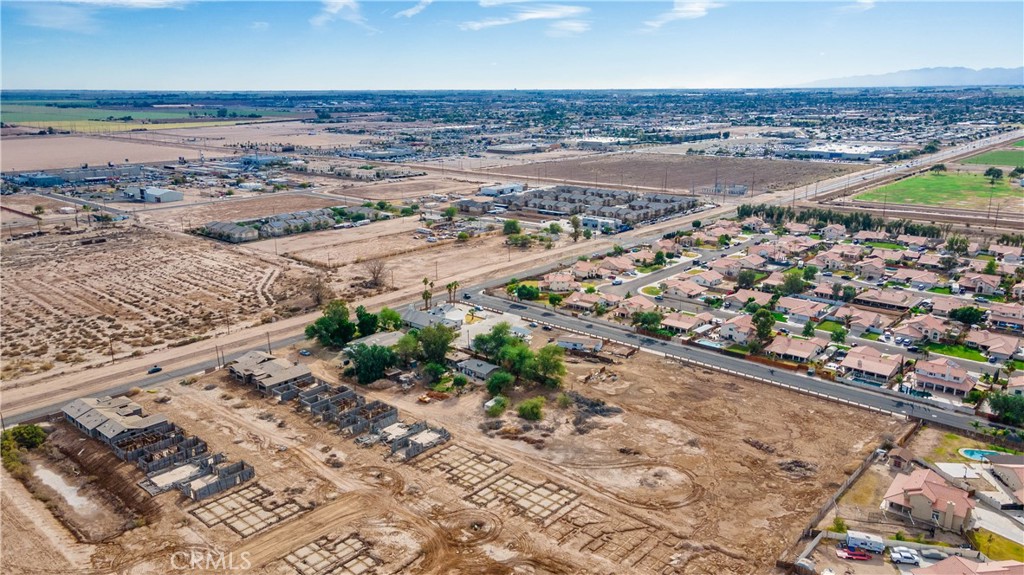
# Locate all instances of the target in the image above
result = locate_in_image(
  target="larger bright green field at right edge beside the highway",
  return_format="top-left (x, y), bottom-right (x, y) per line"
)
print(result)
top-left (855, 172), bottom-right (1021, 211)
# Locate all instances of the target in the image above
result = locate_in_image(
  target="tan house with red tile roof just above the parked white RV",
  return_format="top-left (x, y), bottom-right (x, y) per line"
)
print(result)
top-left (883, 469), bottom-right (975, 533)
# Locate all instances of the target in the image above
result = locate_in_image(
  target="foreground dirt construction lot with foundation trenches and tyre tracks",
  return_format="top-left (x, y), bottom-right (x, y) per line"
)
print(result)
top-left (3, 341), bottom-right (902, 575)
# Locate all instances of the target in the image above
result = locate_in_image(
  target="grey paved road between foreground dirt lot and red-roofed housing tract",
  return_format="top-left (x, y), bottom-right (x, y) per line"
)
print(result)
top-left (471, 294), bottom-right (984, 430)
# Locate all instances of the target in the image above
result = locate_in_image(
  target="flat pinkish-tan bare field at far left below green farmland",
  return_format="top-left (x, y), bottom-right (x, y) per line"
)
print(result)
top-left (0, 136), bottom-right (218, 172)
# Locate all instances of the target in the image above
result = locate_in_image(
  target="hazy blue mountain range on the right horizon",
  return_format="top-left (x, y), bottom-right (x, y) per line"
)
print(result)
top-left (801, 68), bottom-right (1024, 88)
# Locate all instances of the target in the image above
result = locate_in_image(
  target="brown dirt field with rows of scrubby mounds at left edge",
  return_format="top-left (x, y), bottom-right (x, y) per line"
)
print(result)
top-left (0, 228), bottom-right (311, 382)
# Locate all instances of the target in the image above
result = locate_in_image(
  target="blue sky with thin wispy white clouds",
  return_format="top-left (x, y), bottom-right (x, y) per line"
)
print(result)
top-left (0, 0), bottom-right (1024, 90)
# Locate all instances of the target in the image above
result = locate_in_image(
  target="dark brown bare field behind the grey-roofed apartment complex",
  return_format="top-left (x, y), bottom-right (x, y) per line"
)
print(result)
top-left (489, 152), bottom-right (865, 192)
